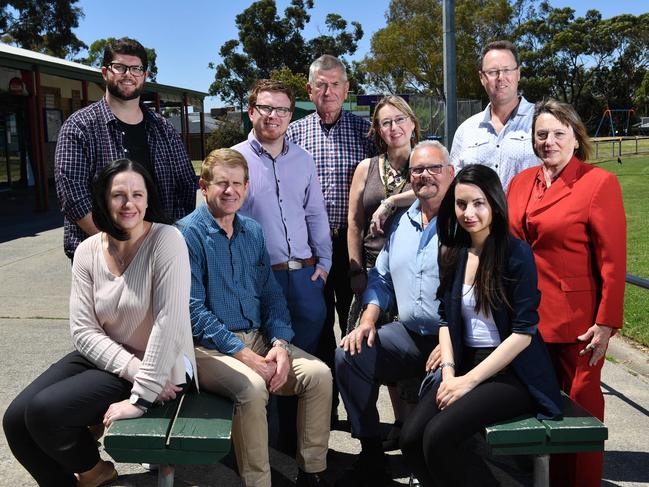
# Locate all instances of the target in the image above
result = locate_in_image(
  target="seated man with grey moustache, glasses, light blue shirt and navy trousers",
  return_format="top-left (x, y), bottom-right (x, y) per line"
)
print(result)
top-left (335, 140), bottom-right (455, 487)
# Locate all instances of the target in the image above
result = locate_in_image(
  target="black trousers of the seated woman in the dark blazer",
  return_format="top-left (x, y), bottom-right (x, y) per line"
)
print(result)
top-left (400, 349), bottom-right (534, 487)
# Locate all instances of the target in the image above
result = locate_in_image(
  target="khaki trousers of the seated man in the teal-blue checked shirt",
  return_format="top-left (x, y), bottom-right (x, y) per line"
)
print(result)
top-left (196, 330), bottom-right (332, 487)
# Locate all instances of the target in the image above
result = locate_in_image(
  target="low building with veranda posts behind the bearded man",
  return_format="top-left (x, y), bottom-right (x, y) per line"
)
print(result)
top-left (0, 43), bottom-right (208, 211)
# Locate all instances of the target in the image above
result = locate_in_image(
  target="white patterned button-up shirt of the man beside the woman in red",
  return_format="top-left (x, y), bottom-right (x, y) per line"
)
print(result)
top-left (451, 97), bottom-right (540, 190)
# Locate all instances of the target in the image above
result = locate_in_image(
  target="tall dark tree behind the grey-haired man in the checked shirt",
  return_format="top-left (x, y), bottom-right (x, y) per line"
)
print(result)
top-left (209, 0), bottom-right (363, 109)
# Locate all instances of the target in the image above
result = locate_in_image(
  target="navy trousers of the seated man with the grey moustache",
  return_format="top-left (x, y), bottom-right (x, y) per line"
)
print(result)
top-left (336, 322), bottom-right (437, 439)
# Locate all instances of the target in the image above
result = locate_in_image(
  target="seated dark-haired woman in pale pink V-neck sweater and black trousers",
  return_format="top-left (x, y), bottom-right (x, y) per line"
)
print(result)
top-left (3, 159), bottom-right (196, 487)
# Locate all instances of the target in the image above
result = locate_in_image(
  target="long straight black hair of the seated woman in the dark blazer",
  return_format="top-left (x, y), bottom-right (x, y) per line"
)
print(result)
top-left (437, 164), bottom-right (510, 314)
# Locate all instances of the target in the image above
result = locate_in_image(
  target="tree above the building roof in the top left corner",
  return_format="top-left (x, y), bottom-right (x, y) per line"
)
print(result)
top-left (0, 0), bottom-right (87, 58)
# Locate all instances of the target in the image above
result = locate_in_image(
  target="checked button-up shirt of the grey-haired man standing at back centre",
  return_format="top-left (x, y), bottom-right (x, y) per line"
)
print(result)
top-left (286, 110), bottom-right (376, 229)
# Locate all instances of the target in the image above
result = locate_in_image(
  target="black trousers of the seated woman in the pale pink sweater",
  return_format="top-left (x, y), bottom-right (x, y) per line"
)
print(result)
top-left (2, 351), bottom-right (133, 487)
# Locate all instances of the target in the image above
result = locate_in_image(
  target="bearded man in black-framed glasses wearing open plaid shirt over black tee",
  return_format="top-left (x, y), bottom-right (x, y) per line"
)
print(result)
top-left (54, 37), bottom-right (198, 259)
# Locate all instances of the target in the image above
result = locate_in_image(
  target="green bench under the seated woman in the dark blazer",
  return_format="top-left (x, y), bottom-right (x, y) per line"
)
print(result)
top-left (485, 394), bottom-right (608, 487)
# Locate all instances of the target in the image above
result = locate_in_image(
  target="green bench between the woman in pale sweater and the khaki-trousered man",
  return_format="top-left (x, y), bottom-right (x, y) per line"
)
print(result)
top-left (104, 392), bottom-right (233, 487)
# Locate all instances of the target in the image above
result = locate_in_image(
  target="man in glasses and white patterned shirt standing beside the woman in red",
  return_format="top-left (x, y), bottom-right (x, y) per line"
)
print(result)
top-left (451, 40), bottom-right (539, 189)
